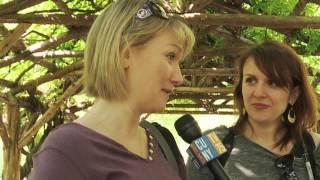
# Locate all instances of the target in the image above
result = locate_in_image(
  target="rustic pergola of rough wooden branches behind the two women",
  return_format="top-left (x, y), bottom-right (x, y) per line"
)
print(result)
top-left (0, 0), bottom-right (320, 180)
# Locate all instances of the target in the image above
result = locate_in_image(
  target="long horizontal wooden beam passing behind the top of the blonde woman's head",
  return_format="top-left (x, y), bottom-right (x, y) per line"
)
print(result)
top-left (0, 13), bottom-right (320, 29)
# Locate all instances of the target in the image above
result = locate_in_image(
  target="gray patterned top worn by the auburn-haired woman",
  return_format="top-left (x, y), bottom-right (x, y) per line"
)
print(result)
top-left (187, 127), bottom-right (320, 180)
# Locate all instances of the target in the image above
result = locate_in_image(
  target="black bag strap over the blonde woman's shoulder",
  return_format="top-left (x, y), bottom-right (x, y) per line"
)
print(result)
top-left (140, 120), bottom-right (180, 174)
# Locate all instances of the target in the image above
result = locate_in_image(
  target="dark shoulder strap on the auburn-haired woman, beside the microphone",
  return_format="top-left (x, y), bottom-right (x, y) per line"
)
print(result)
top-left (218, 127), bottom-right (234, 166)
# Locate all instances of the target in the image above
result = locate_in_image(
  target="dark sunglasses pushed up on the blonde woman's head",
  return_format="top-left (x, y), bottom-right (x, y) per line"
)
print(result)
top-left (136, 0), bottom-right (168, 20)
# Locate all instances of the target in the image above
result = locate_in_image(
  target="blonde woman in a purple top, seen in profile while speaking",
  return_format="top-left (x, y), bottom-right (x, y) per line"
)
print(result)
top-left (29, 0), bottom-right (194, 180)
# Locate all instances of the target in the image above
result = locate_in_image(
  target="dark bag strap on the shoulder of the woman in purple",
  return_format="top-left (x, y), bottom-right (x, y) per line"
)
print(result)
top-left (140, 120), bottom-right (182, 175)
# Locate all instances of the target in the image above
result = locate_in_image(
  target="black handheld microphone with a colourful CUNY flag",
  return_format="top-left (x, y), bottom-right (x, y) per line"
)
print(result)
top-left (174, 114), bottom-right (230, 180)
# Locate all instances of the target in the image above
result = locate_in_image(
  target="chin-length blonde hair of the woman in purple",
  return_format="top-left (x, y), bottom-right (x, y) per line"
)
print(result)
top-left (83, 0), bottom-right (195, 100)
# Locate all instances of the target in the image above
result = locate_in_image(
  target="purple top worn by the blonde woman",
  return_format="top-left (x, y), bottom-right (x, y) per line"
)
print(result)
top-left (28, 123), bottom-right (185, 180)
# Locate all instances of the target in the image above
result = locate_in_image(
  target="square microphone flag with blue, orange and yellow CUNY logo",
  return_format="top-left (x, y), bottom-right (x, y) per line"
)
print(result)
top-left (187, 132), bottom-right (227, 168)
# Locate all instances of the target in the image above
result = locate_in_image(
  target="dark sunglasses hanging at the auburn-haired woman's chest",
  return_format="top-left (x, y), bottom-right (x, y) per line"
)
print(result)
top-left (275, 154), bottom-right (298, 180)
